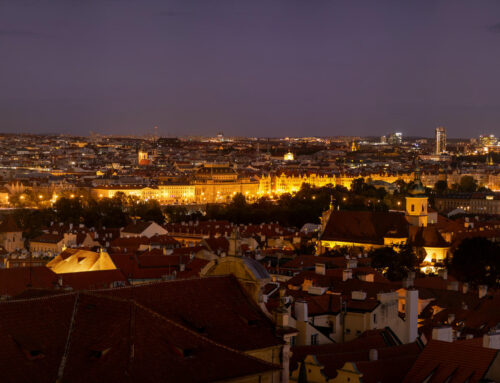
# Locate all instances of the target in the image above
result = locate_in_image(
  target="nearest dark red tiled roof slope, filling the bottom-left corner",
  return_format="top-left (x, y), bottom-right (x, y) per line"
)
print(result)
top-left (0, 293), bottom-right (277, 383)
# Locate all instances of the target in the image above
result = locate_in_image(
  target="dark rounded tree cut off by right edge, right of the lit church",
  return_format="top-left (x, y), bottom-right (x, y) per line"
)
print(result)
top-left (448, 237), bottom-right (500, 287)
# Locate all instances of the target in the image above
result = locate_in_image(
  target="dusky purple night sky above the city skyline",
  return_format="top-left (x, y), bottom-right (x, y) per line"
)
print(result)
top-left (0, 0), bottom-right (500, 137)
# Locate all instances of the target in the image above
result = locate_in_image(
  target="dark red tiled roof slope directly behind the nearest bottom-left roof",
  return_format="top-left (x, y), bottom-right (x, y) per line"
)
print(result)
top-left (102, 276), bottom-right (282, 351)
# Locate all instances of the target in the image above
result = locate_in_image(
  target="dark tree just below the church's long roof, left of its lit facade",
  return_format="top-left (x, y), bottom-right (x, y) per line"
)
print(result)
top-left (370, 245), bottom-right (418, 281)
